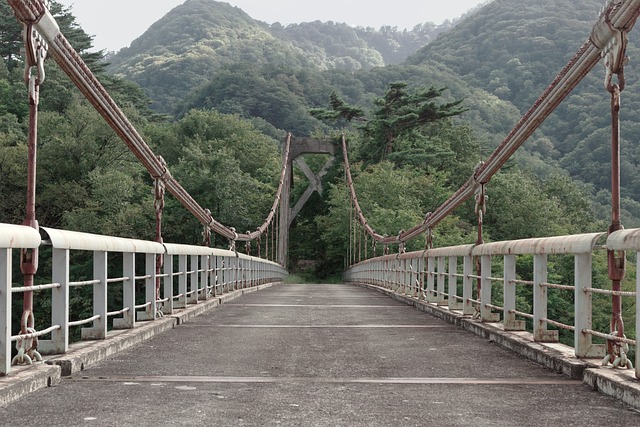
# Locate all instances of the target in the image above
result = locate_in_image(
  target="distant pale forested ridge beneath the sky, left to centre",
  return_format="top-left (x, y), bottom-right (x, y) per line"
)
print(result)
top-left (109, 0), bottom-right (450, 113)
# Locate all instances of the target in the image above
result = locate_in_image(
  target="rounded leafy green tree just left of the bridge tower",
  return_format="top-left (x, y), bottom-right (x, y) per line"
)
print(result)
top-left (151, 110), bottom-right (281, 244)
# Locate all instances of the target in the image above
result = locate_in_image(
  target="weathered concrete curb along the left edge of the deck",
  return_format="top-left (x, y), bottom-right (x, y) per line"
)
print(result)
top-left (0, 283), bottom-right (275, 407)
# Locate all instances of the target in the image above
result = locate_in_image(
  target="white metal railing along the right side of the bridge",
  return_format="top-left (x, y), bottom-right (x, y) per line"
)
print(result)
top-left (345, 229), bottom-right (640, 378)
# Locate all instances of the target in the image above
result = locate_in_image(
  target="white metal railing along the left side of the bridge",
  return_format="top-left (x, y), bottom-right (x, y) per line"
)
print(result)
top-left (0, 224), bottom-right (287, 376)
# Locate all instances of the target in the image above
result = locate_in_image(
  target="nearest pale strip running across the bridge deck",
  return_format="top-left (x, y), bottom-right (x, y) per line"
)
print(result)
top-left (65, 375), bottom-right (583, 386)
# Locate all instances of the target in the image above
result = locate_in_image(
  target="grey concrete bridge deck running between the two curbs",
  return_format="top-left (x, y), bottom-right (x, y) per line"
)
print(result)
top-left (0, 285), bottom-right (640, 426)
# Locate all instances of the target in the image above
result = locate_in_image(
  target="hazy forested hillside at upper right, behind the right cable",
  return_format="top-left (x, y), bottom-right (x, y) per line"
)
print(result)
top-left (408, 0), bottom-right (640, 226)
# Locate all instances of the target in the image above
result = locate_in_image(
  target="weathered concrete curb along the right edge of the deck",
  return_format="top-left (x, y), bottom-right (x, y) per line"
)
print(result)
top-left (353, 283), bottom-right (640, 409)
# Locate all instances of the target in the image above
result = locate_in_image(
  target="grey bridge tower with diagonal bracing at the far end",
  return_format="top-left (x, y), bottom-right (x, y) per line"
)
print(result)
top-left (278, 137), bottom-right (336, 268)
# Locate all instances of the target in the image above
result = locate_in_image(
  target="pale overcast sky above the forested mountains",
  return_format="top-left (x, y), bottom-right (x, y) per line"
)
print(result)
top-left (58, 0), bottom-right (487, 51)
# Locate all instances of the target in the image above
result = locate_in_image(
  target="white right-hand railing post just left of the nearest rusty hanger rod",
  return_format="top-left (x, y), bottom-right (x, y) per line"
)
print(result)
top-left (574, 253), bottom-right (606, 358)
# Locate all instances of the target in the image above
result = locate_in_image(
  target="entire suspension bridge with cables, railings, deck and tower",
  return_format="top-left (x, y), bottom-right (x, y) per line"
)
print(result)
top-left (0, 0), bottom-right (640, 425)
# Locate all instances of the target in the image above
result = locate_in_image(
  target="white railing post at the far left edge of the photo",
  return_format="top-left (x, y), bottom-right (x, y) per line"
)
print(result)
top-left (0, 248), bottom-right (13, 376)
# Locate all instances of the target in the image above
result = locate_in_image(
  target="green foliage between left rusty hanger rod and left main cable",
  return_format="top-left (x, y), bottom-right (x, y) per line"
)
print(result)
top-left (37, 97), bottom-right (153, 237)
